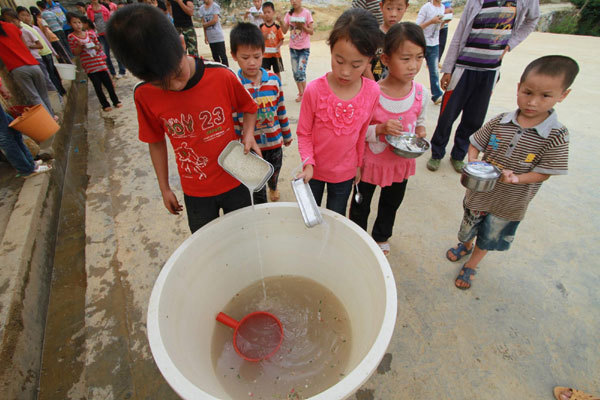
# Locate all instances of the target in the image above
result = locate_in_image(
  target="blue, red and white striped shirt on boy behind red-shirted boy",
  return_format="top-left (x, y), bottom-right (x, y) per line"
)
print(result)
top-left (233, 68), bottom-right (292, 150)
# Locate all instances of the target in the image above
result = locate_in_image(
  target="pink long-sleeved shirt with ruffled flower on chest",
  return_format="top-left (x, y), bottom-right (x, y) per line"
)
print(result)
top-left (296, 74), bottom-right (379, 183)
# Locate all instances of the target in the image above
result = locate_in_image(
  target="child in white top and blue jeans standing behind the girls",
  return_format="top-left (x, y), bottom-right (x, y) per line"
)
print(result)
top-left (415, 0), bottom-right (445, 104)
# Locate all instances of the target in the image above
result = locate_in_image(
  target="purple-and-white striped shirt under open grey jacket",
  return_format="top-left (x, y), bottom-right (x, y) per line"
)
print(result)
top-left (456, 0), bottom-right (517, 70)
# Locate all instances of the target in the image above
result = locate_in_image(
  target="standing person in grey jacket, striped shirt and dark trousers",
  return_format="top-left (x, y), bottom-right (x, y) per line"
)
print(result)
top-left (427, 0), bottom-right (540, 173)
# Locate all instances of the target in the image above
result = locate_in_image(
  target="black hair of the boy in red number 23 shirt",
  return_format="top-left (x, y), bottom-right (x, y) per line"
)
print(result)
top-left (106, 3), bottom-right (184, 88)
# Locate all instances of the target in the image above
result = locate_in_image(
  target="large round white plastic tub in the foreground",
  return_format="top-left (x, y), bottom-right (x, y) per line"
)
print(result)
top-left (148, 203), bottom-right (397, 400)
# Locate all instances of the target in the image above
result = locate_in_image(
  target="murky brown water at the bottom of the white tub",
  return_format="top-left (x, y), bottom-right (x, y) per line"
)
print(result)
top-left (211, 275), bottom-right (351, 400)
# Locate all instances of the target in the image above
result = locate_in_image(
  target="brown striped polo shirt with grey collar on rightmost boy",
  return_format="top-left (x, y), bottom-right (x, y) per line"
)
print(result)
top-left (465, 110), bottom-right (569, 221)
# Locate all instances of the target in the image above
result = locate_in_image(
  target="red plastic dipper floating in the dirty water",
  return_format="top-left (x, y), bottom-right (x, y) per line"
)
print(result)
top-left (217, 311), bottom-right (283, 362)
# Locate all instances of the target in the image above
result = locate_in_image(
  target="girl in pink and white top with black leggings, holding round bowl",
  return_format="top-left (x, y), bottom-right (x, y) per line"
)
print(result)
top-left (350, 21), bottom-right (427, 256)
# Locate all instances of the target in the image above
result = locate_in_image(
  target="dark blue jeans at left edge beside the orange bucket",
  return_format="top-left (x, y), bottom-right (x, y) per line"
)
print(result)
top-left (0, 107), bottom-right (35, 175)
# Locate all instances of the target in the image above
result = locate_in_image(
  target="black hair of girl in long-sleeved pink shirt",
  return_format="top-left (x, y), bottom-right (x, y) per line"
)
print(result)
top-left (327, 8), bottom-right (383, 57)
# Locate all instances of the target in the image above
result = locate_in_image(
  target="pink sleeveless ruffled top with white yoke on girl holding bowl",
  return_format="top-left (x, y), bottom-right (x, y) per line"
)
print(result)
top-left (361, 81), bottom-right (429, 187)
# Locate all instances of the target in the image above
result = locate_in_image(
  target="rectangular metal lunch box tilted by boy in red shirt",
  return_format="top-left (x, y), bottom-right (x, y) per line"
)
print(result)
top-left (217, 140), bottom-right (275, 192)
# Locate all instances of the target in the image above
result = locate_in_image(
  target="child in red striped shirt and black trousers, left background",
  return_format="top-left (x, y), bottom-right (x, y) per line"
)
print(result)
top-left (67, 13), bottom-right (123, 111)
